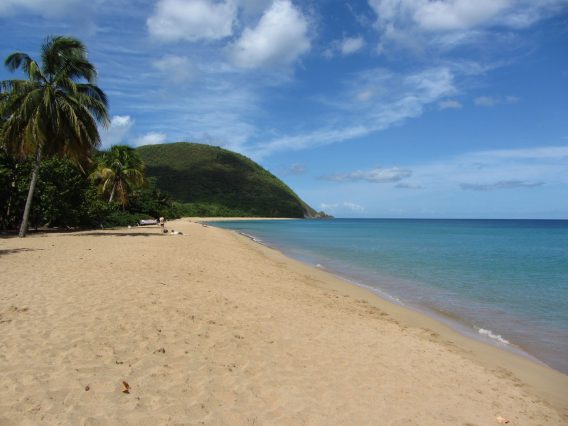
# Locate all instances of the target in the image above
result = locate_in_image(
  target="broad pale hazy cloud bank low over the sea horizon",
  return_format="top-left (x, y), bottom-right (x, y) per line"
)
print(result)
top-left (312, 144), bottom-right (568, 218)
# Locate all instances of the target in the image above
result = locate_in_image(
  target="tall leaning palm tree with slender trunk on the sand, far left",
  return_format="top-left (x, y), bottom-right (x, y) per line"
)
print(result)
top-left (0, 36), bottom-right (109, 237)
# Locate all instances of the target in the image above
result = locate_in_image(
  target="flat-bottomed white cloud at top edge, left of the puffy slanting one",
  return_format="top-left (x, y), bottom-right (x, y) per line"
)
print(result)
top-left (146, 0), bottom-right (237, 42)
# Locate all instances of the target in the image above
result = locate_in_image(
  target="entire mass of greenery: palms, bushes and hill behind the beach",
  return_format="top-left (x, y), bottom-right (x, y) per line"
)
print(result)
top-left (0, 36), bottom-right (325, 233)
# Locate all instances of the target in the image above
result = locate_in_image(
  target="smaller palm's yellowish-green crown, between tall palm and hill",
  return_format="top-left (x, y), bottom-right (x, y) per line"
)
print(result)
top-left (91, 145), bottom-right (144, 209)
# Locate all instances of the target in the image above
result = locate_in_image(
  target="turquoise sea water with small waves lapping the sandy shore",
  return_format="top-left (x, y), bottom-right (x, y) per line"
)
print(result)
top-left (212, 219), bottom-right (568, 373)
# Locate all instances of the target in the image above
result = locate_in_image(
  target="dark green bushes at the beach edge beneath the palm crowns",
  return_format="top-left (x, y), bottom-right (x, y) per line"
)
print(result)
top-left (0, 151), bottom-right (179, 229)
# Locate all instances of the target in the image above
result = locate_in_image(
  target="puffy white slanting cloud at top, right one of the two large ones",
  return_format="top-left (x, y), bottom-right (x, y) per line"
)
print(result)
top-left (229, 0), bottom-right (310, 69)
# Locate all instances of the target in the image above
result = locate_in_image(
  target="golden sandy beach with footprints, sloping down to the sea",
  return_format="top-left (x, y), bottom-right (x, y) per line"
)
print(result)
top-left (0, 220), bottom-right (568, 425)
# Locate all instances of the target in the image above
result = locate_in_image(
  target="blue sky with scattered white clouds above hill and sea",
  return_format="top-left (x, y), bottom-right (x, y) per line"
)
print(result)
top-left (0, 0), bottom-right (568, 219)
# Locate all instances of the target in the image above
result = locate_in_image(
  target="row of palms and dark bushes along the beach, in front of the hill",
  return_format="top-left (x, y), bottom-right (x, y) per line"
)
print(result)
top-left (0, 36), bottom-right (178, 237)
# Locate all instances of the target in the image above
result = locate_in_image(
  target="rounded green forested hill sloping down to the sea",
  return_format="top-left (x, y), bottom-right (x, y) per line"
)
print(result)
top-left (137, 142), bottom-right (317, 218)
